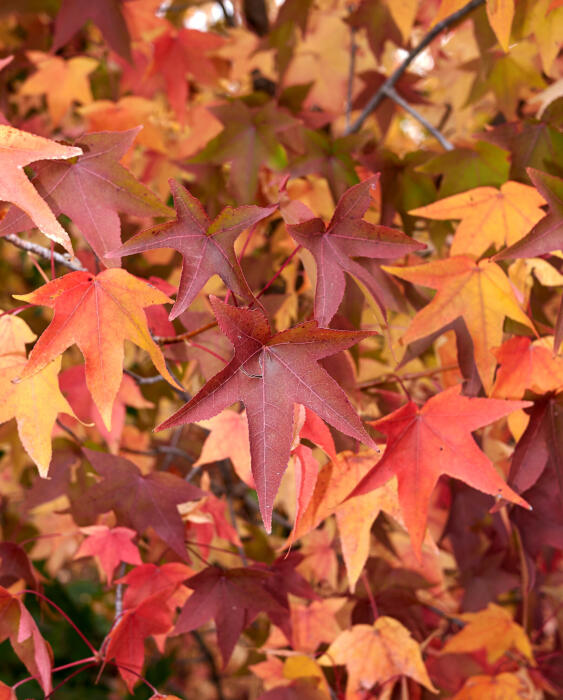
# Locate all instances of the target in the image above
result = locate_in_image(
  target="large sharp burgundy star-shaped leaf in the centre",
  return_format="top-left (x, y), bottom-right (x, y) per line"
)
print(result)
top-left (157, 297), bottom-right (373, 530)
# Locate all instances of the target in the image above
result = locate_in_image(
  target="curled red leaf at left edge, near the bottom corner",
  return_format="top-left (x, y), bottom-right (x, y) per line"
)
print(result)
top-left (0, 586), bottom-right (52, 695)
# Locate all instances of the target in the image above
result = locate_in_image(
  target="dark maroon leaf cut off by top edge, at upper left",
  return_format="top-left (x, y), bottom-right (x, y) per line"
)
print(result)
top-left (52, 0), bottom-right (131, 61)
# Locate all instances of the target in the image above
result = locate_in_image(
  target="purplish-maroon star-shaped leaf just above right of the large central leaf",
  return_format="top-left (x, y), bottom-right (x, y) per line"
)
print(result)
top-left (287, 176), bottom-right (425, 327)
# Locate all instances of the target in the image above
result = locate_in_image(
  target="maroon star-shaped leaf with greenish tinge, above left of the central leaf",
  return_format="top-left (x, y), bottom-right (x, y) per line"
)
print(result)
top-left (111, 180), bottom-right (276, 319)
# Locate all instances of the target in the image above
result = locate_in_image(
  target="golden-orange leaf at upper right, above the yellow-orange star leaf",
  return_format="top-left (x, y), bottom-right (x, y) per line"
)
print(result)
top-left (409, 180), bottom-right (545, 258)
